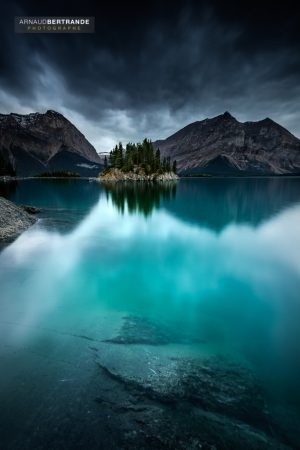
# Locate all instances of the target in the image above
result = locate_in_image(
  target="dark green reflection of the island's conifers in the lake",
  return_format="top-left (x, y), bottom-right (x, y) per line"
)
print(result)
top-left (104, 182), bottom-right (176, 217)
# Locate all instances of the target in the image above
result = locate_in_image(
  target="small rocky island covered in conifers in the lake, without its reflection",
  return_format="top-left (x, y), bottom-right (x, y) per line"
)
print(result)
top-left (98, 139), bottom-right (179, 182)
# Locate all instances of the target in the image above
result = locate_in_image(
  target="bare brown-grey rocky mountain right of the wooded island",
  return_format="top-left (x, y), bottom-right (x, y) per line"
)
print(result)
top-left (153, 112), bottom-right (300, 175)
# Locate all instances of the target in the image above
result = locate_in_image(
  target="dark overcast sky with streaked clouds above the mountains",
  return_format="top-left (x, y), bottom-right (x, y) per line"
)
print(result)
top-left (0, 0), bottom-right (300, 151)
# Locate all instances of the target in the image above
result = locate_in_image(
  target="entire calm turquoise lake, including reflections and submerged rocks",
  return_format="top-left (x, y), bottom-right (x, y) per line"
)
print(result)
top-left (0, 178), bottom-right (300, 450)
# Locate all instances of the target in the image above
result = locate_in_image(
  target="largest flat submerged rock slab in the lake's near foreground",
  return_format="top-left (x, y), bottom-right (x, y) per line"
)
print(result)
top-left (98, 349), bottom-right (269, 430)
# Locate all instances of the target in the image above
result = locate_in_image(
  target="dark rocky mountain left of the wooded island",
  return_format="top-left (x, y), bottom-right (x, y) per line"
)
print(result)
top-left (0, 110), bottom-right (103, 176)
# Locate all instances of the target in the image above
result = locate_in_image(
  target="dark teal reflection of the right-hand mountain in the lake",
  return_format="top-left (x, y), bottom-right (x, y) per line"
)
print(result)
top-left (164, 178), bottom-right (300, 231)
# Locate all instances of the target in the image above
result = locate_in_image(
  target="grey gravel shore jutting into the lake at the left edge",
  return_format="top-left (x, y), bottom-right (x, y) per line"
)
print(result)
top-left (0, 197), bottom-right (37, 241)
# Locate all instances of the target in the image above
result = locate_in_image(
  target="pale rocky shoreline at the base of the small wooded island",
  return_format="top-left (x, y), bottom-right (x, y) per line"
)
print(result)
top-left (97, 168), bottom-right (179, 182)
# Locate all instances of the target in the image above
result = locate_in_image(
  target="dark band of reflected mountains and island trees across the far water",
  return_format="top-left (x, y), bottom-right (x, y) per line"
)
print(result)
top-left (0, 178), bottom-right (300, 232)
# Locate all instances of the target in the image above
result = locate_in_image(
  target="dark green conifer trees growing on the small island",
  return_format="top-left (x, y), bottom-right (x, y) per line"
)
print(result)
top-left (104, 139), bottom-right (177, 175)
